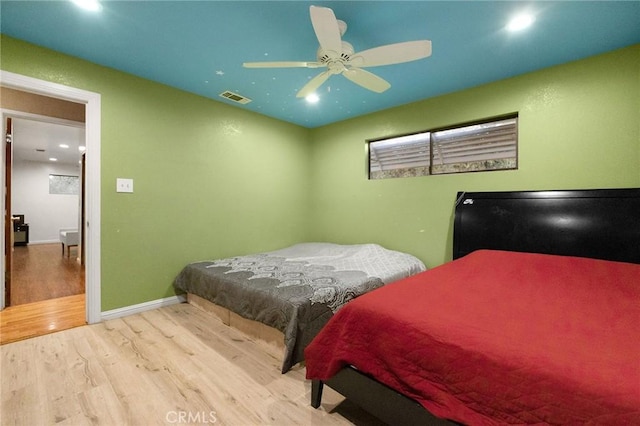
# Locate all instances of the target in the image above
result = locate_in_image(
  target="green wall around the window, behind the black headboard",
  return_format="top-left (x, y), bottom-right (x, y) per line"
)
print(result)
top-left (311, 45), bottom-right (640, 267)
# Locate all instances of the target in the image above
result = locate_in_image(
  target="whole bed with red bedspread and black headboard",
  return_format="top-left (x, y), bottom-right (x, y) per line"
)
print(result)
top-left (305, 189), bottom-right (640, 425)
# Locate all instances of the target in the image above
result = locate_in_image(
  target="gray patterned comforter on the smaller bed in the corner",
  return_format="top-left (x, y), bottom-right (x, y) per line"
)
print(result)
top-left (174, 243), bottom-right (426, 373)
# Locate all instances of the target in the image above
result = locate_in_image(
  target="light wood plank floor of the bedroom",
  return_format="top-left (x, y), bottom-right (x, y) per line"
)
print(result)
top-left (0, 304), bottom-right (380, 426)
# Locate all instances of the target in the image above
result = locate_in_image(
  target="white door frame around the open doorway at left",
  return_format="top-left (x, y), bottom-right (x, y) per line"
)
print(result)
top-left (0, 71), bottom-right (102, 324)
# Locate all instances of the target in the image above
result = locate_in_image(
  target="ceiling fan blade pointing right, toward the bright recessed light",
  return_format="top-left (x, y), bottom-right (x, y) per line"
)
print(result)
top-left (350, 40), bottom-right (431, 67)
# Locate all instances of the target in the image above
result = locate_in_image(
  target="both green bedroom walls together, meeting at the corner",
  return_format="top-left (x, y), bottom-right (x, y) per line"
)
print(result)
top-left (1, 36), bottom-right (640, 311)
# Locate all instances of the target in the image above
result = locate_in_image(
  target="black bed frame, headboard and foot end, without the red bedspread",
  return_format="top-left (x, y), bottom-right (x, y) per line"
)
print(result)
top-left (311, 188), bottom-right (640, 425)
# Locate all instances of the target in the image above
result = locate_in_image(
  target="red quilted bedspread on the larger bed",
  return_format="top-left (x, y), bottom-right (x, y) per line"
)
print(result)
top-left (305, 250), bottom-right (640, 425)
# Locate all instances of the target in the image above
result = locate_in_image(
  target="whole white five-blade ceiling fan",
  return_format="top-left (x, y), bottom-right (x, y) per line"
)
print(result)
top-left (243, 6), bottom-right (431, 98)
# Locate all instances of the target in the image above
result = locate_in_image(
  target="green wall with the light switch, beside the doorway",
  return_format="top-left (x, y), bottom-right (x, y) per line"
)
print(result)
top-left (1, 36), bottom-right (310, 311)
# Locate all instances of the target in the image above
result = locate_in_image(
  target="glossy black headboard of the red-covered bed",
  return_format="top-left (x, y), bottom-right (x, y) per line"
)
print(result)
top-left (453, 188), bottom-right (640, 263)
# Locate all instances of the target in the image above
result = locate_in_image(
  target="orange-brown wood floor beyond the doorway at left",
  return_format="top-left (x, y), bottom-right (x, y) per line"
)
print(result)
top-left (0, 244), bottom-right (86, 344)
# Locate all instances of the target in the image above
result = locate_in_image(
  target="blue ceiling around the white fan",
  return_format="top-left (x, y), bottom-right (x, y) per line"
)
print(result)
top-left (0, 0), bottom-right (640, 127)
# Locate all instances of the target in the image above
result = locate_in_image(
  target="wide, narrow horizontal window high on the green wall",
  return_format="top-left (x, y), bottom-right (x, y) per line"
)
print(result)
top-left (368, 115), bottom-right (518, 179)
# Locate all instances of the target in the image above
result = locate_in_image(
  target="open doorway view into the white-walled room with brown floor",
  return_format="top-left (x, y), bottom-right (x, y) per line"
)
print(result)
top-left (7, 115), bottom-right (86, 307)
